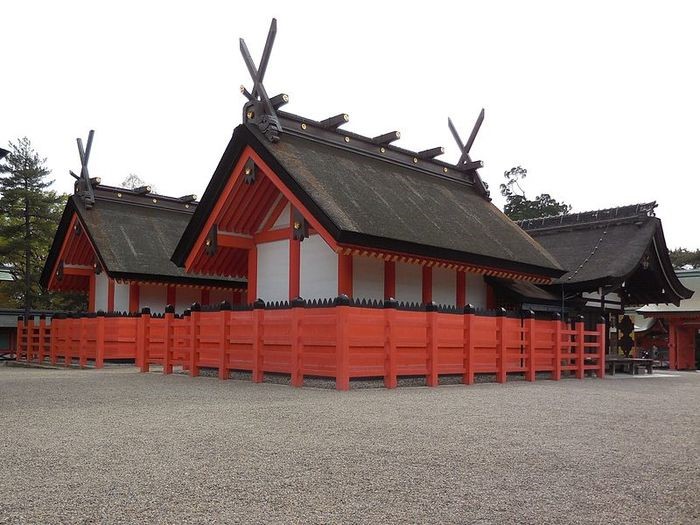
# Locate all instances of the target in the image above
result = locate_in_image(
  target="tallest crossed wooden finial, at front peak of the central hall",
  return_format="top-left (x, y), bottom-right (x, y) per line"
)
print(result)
top-left (240, 18), bottom-right (289, 142)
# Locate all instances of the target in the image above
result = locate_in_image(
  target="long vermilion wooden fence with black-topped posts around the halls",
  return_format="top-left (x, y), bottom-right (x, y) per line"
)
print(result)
top-left (18, 297), bottom-right (605, 390)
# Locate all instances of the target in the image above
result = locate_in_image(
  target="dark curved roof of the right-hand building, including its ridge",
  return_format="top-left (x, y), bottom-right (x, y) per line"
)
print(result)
top-left (519, 202), bottom-right (692, 304)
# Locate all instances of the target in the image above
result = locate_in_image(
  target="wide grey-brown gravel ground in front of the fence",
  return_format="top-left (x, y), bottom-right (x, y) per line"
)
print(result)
top-left (0, 366), bottom-right (700, 524)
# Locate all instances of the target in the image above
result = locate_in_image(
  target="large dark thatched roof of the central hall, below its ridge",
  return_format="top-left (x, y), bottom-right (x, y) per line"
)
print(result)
top-left (173, 125), bottom-right (563, 277)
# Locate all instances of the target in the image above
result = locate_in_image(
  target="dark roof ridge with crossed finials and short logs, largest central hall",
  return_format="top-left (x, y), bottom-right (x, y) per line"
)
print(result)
top-left (239, 18), bottom-right (489, 199)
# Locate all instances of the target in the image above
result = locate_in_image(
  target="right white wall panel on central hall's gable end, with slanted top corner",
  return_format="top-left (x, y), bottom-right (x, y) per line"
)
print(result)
top-left (299, 234), bottom-right (338, 300)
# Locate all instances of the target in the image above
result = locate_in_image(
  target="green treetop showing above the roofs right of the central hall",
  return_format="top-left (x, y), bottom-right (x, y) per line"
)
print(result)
top-left (500, 166), bottom-right (571, 221)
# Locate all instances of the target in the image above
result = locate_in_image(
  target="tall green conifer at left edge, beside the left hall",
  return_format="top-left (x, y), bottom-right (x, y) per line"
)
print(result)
top-left (0, 137), bottom-right (84, 311)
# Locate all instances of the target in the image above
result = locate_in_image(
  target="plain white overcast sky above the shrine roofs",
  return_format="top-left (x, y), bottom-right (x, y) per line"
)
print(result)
top-left (0, 0), bottom-right (700, 249)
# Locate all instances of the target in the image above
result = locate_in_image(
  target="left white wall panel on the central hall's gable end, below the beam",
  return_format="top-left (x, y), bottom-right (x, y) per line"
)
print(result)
top-left (258, 239), bottom-right (290, 301)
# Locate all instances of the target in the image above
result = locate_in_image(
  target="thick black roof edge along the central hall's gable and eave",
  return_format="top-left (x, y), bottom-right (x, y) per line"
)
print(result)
top-left (171, 124), bottom-right (566, 278)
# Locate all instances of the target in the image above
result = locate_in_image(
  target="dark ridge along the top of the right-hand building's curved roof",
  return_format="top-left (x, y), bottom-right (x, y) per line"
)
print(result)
top-left (515, 201), bottom-right (657, 231)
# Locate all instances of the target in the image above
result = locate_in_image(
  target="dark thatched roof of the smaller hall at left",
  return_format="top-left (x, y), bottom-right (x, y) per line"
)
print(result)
top-left (41, 186), bottom-right (245, 287)
